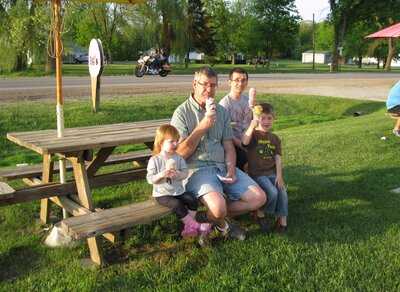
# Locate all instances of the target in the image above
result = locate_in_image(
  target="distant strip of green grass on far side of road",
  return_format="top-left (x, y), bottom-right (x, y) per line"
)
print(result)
top-left (0, 60), bottom-right (400, 77)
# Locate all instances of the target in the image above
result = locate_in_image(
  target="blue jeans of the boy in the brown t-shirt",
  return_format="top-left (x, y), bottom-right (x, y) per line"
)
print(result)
top-left (254, 174), bottom-right (288, 217)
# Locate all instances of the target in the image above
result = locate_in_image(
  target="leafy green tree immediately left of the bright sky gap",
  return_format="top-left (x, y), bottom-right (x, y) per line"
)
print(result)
top-left (253, 0), bottom-right (300, 67)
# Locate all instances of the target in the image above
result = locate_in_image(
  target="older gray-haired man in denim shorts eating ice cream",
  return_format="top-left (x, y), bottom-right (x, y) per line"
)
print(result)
top-left (171, 67), bottom-right (266, 240)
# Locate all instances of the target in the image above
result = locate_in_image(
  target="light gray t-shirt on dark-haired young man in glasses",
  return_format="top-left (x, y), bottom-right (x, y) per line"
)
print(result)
top-left (219, 94), bottom-right (253, 140)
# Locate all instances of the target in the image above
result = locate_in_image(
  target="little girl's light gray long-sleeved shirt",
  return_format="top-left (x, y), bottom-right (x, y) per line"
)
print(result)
top-left (146, 154), bottom-right (188, 197)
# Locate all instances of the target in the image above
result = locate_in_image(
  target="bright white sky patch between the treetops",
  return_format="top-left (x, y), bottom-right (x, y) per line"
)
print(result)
top-left (295, 0), bottom-right (329, 22)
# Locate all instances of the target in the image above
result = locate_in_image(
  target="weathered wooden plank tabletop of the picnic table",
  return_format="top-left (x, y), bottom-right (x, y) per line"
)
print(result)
top-left (7, 119), bottom-right (170, 155)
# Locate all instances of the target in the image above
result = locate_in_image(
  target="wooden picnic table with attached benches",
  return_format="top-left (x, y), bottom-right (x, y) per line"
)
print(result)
top-left (0, 119), bottom-right (169, 265)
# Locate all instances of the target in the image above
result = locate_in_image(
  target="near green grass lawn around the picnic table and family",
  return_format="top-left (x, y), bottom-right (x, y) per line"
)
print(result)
top-left (0, 95), bottom-right (400, 291)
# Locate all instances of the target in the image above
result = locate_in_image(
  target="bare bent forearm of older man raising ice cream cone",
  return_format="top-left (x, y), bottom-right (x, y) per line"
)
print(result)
top-left (176, 116), bottom-right (215, 159)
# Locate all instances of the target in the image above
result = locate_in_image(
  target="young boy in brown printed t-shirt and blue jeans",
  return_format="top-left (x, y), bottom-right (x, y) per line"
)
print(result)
top-left (242, 103), bottom-right (288, 233)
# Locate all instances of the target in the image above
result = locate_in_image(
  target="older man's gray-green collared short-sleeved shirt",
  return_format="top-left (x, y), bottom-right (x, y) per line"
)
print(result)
top-left (171, 96), bottom-right (233, 169)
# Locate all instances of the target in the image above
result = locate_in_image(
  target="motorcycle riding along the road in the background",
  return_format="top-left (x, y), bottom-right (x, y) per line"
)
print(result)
top-left (135, 56), bottom-right (171, 77)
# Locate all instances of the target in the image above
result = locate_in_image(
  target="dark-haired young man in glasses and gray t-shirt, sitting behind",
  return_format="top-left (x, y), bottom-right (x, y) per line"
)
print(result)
top-left (219, 68), bottom-right (255, 170)
